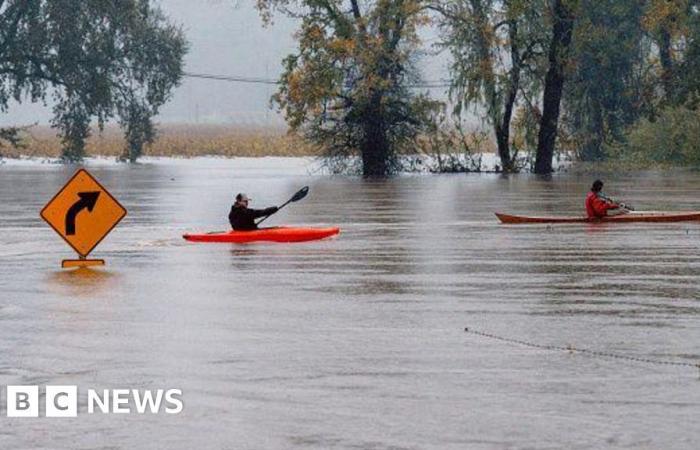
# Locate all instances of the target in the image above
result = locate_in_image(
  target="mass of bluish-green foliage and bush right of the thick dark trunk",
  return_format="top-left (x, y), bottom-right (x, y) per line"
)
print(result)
top-left (565, 0), bottom-right (700, 165)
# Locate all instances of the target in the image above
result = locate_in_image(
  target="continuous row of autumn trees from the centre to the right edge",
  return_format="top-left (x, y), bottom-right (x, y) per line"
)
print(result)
top-left (257, 0), bottom-right (700, 175)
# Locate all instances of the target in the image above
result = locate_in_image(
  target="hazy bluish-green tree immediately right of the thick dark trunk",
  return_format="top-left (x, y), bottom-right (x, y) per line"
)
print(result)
top-left (562, 0), bottom-right (650, 161)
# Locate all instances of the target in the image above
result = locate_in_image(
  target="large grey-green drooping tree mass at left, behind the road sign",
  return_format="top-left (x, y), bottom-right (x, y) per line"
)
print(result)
top-left (0, 0), bottom-right (186, 161)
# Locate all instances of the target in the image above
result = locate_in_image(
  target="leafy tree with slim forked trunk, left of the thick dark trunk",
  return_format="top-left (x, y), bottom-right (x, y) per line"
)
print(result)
top-left (431, 0), bottom-right (545, 172)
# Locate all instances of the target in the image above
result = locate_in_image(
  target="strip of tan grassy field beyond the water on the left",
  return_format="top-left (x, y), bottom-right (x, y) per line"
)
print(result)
top-left (0, 124), bottom-right (317, 158)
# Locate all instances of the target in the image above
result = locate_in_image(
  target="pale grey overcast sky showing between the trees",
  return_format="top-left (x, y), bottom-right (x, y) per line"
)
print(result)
top-left (0, 0), bottom-right (446, 125)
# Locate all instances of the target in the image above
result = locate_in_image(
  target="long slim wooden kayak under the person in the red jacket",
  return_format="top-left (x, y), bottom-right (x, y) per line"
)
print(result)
top-left (496, 211), bottom-right (700, 224)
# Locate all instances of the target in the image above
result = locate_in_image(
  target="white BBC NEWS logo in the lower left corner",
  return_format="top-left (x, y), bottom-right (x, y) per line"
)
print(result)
top-left (5, 386), bottom-right (184, 417)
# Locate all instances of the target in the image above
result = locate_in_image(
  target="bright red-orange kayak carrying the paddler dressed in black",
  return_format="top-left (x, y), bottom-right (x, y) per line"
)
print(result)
top-left (182, 227), bottom-right (340, 244)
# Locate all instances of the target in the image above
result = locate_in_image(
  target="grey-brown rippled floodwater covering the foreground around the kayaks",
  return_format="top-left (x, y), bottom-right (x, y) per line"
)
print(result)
top-left (0, 159), bottom-right (700, 449)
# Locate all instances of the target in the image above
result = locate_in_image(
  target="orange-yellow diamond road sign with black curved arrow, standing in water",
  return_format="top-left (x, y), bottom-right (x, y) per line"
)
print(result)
top-left (41, 169), bottom-right (126, 268)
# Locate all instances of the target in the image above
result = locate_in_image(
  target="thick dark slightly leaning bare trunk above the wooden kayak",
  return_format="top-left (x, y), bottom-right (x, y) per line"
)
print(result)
top-left (535, 0), bottom-right (575, 174)
